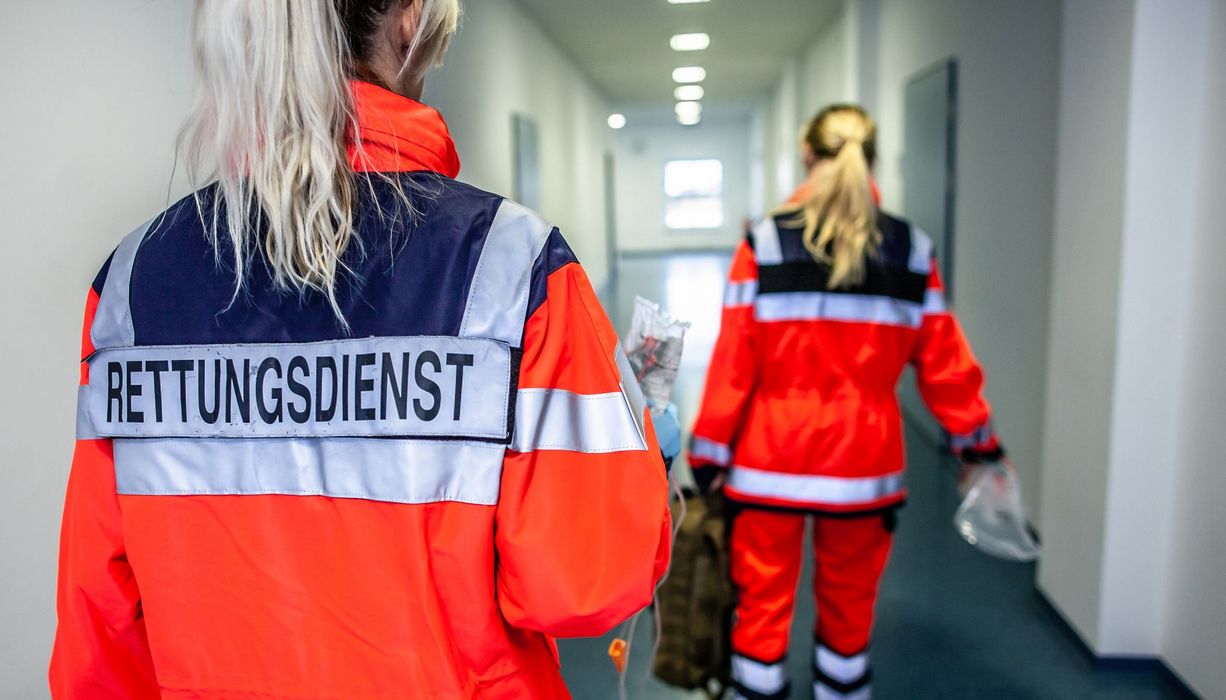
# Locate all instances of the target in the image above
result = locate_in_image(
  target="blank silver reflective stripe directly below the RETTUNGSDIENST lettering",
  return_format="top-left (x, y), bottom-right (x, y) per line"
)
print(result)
top-left (114, 438), bottom-right (504, 505)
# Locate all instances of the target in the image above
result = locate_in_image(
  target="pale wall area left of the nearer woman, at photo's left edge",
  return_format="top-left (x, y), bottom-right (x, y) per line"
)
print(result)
top-left (0, 0), bottom-right (191, 699)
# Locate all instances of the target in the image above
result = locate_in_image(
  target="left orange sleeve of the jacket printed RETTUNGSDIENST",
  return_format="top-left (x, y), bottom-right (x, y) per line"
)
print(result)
top-left (50, 289), bottom-right (161, 700)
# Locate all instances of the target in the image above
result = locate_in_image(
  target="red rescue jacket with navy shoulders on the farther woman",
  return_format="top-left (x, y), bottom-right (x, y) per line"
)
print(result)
top-left (690, 205), bottom-right (999, 512)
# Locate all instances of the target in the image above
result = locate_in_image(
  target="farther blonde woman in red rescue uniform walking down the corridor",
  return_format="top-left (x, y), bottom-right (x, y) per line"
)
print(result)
top-left (690, 104), bottom-right (1004, 700)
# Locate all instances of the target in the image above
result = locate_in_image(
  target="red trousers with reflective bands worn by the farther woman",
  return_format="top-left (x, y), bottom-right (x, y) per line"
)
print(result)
top-left (732, 509), bottom-right (893, 700)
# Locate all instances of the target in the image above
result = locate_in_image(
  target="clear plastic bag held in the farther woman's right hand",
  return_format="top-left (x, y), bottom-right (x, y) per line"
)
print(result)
top-left (954, 463), bottom-right (1040, 561)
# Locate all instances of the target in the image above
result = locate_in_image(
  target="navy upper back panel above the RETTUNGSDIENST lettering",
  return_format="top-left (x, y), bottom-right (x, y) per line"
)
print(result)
top-left (131, 173), bottom-right (503, 346)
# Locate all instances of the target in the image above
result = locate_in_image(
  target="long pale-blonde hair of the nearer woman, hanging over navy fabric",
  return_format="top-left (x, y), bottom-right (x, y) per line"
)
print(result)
top-left (179, 0), bottom-right (460, 326)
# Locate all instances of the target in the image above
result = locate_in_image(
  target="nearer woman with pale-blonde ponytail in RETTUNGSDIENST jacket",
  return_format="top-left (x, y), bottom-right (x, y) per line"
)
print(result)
top-left (50, 0), bottom-right (671, 700)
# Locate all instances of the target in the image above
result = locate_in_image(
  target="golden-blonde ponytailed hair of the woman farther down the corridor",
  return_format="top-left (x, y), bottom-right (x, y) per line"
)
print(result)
top-left (791, 104), bottom-right (881, 289)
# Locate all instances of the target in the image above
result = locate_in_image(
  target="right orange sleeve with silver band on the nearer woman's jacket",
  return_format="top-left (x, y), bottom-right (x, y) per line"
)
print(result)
top-left (495, 241), bottom-right (672, 637)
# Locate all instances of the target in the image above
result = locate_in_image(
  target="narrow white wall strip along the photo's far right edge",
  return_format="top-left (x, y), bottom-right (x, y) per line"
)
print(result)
top-left (1162, 0), bottom-right (1226, 698)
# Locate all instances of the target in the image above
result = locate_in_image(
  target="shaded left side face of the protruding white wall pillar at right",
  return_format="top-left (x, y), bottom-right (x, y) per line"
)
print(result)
top-left (1038, 0), bottom-right (1134, 646)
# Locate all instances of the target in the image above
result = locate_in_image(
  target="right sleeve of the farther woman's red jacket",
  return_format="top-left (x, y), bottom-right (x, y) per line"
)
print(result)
top-left (911, 261), bottom-right (1004, 461)
